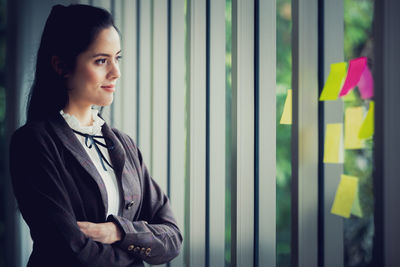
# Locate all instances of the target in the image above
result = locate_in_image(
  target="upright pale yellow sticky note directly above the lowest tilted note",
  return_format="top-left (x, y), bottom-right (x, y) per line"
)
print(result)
top-left (324, 123), bottom-right (343, 163)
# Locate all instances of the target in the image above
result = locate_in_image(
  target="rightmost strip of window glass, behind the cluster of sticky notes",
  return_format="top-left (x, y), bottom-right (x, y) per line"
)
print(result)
top-left (344, 0), bottom-right (374, 267)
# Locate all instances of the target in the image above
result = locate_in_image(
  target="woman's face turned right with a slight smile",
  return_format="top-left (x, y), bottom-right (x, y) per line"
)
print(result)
top-left (67, 27), bottom-right (121, 107)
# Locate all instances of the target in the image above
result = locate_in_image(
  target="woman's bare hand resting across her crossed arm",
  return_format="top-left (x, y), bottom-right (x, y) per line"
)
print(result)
top-left (77, 222), bottom-right (121, 244)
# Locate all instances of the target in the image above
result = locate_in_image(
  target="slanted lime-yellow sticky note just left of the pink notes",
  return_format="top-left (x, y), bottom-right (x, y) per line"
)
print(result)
top-left (319, 62), bottom-right (347, 101)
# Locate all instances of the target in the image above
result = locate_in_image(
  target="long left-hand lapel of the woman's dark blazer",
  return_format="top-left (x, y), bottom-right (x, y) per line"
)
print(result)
top-left (50, 114), bottom-right (108, 217)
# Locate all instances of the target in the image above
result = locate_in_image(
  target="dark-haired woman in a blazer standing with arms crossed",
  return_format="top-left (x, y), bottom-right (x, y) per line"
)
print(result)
top-left (10, 5), bottom-right (182, 267)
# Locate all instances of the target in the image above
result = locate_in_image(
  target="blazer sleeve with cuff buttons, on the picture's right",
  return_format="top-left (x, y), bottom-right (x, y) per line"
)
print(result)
top-left (108, 132), bottom-right (182, 264)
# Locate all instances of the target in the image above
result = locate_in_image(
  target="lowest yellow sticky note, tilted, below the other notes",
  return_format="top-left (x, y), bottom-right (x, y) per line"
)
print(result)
top-left (331, 174), bottom-right (358, 218)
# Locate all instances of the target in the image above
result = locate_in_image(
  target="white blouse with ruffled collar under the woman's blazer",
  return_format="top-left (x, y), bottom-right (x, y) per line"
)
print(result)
top-left (60, 109), bottom-right (121, 216)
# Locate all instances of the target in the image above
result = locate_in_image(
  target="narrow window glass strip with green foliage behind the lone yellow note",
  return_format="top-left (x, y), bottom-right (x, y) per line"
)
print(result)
top-left (276, 0), bottom-right (292, 267)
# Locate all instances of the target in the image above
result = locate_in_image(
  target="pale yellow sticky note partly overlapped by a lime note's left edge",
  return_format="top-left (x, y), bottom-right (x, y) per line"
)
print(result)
top-left (344, 107), bottom-right (364, 149)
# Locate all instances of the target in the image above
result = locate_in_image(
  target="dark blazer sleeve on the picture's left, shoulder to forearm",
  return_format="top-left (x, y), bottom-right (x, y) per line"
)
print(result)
top-left (10, 127), bottom-right (142, 267)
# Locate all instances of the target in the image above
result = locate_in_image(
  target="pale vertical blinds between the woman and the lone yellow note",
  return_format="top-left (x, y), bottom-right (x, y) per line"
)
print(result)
top-left (90, 0), bottom-right (276, 266)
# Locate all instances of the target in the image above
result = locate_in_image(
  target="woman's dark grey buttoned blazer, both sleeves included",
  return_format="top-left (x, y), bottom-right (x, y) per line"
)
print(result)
top-left (10, 114), bottom-right (182, 267)
